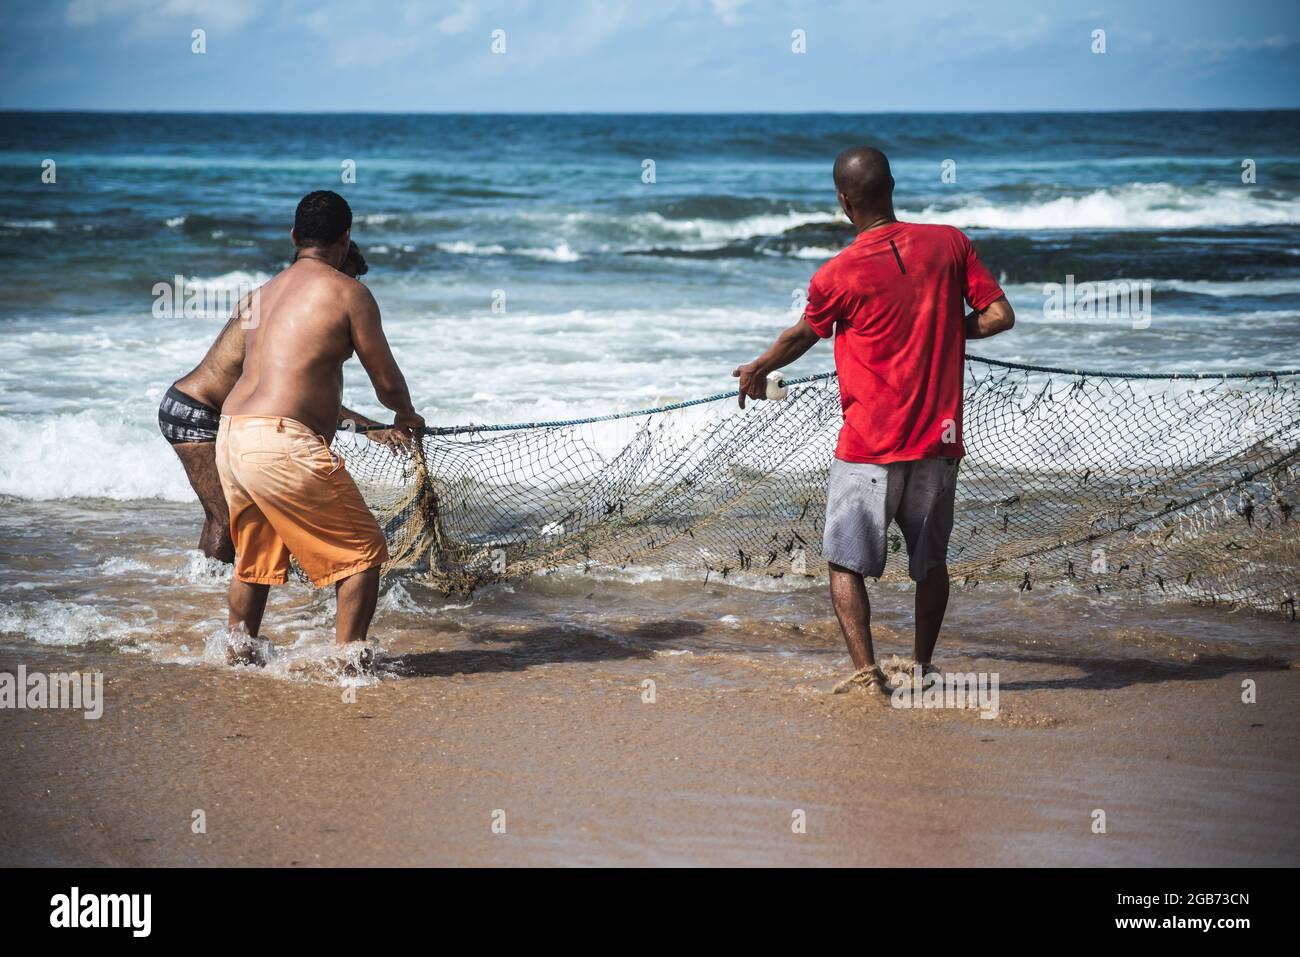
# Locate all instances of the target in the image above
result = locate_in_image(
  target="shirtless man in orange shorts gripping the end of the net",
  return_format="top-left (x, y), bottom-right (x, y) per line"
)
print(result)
top-left (216, 190), bottom-right (424, 663)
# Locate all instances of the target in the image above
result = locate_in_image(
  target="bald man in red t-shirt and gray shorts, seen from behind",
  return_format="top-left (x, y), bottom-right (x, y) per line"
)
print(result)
top-left (732, 147), bottom-right (1015, 694)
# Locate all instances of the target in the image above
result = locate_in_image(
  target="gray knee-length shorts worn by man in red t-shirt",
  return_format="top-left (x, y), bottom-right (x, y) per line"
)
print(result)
top-left (822, 459), bottom-right (961, 581)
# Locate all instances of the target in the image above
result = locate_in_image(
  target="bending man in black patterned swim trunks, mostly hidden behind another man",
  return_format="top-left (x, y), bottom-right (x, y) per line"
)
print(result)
top-left (159, 243), bottom-right (389, 564)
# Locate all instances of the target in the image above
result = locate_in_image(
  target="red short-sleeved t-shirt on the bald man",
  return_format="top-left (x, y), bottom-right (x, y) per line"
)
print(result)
top-left (803, 222), bottom-right (1002, 464)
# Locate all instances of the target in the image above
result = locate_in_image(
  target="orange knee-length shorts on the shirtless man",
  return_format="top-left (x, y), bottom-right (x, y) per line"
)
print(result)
top-left (217, 415), bottom-right (389, 588)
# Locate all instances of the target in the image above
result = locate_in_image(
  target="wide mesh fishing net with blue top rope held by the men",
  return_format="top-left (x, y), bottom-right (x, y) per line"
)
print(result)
top-left (327, 356), bottom-right (1300, 619)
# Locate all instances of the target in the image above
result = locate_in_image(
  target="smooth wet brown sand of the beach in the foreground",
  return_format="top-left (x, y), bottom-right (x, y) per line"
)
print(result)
top-left (0, 598), bottom-right (1300, 866)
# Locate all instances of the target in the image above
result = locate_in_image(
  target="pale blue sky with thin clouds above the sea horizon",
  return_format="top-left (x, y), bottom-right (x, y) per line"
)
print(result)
top-left (0, 0), bottom-right (1300, 112)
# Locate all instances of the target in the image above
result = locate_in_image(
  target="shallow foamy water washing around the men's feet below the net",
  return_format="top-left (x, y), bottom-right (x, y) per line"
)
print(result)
top-left (0, 499), bottom-right (1300, 689)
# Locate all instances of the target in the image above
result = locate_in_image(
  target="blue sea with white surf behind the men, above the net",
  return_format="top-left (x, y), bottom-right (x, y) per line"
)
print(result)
top-left (0, 112), bottom-right (1300, 654)
